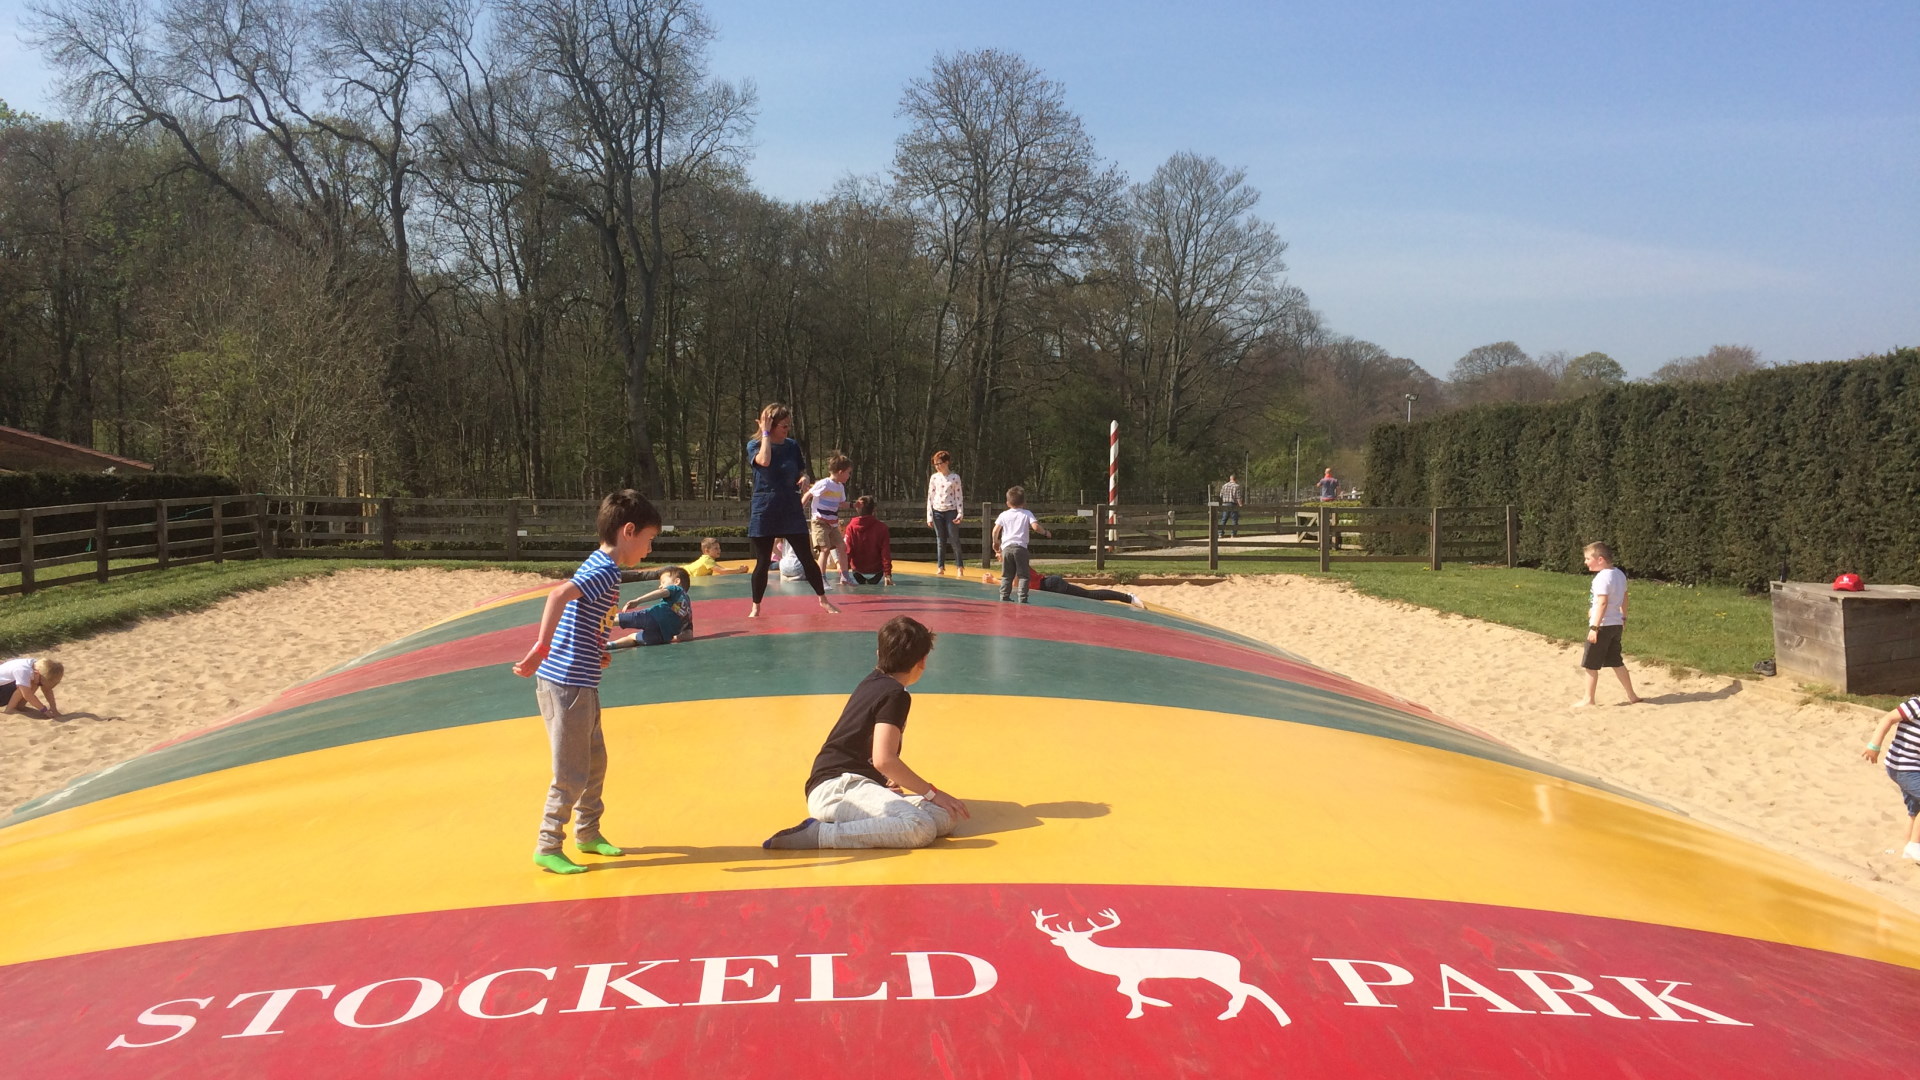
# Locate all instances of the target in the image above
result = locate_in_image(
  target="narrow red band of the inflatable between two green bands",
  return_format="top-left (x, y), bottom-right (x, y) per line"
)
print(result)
top-left (165, 596), bottom-right (1459, 749)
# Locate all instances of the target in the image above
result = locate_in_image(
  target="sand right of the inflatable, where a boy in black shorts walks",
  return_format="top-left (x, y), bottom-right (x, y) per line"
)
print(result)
top-left (1139, 577), bottom-right (1920, 911)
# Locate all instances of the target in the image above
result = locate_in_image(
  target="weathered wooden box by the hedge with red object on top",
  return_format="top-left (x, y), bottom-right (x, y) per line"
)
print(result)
top-left (1772, 580), bottom-right (1920, 694)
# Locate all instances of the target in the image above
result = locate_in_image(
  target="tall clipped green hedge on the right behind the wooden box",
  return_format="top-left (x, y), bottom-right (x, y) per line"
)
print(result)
top-left (1367, 348), bottom-right (1920, 588)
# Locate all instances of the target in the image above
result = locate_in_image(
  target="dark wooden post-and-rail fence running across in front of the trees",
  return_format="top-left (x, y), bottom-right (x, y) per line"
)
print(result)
top-left (0, 494), bottom-right (1519, 596)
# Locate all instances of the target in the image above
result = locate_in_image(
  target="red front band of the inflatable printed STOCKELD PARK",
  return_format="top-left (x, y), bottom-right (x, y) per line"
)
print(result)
top-left (11, 883), bottom-right (1920, 1080)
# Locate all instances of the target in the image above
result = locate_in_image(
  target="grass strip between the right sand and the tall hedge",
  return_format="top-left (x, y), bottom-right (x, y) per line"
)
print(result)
top-left (1044, 559), bottom-right (1899, 709)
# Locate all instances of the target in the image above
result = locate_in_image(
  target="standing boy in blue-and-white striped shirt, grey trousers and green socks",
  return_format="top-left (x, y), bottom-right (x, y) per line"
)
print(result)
top-left (513, 488), bottom-right (660, 874)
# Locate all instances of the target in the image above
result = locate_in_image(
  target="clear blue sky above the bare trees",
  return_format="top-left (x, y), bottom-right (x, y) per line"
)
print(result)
top-left (0, 0), bottom-right (1920, 375)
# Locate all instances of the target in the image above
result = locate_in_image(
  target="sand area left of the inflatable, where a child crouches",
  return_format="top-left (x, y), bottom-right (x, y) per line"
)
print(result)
top-left (0, 569), bottom-right (547, 813)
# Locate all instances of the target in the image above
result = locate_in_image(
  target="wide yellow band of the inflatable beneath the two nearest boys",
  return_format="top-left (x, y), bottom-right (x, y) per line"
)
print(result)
top-left (0, 696), bottom-right (1920, 967)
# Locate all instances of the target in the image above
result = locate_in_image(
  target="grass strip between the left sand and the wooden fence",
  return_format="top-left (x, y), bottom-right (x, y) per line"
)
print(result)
top-left (0, 559), bottom-right (576, 655)
